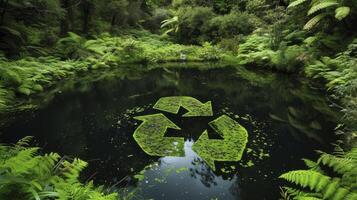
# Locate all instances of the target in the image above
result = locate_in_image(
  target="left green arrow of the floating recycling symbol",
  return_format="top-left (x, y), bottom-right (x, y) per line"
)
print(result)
top-left (133, 113), bottom-right (184, 157)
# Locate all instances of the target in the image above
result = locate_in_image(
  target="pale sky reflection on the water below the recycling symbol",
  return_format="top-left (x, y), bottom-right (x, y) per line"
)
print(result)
top-left (125, 140), bottom-right (240, 199)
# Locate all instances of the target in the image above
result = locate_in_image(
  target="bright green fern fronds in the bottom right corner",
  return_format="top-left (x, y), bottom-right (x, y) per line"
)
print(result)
top-left (280, 148), bottom-right (357, 200)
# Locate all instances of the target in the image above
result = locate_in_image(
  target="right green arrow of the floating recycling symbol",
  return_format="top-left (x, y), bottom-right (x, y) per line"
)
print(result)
top-left (192, 115), bottom-right (248, 170)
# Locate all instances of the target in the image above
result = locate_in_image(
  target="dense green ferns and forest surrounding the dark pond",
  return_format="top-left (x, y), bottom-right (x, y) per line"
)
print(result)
top-left (0, 0), bottom-right (357, 200)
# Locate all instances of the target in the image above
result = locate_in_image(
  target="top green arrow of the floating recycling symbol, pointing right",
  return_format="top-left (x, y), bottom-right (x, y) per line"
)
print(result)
top-left (154, 96), bottom-right (213, 117)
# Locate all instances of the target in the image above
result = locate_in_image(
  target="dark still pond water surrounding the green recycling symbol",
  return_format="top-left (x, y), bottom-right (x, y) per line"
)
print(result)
top-left (0, 66), bottom-right (338, 200)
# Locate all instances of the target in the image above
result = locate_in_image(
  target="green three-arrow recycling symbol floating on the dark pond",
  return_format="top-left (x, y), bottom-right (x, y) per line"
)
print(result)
top-left (133, 96), bottom-right (248, 170)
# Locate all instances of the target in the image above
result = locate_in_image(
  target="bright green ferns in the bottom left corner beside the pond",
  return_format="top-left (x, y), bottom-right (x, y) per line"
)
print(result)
top-left (0, 137), bottom-right (117, 200)
